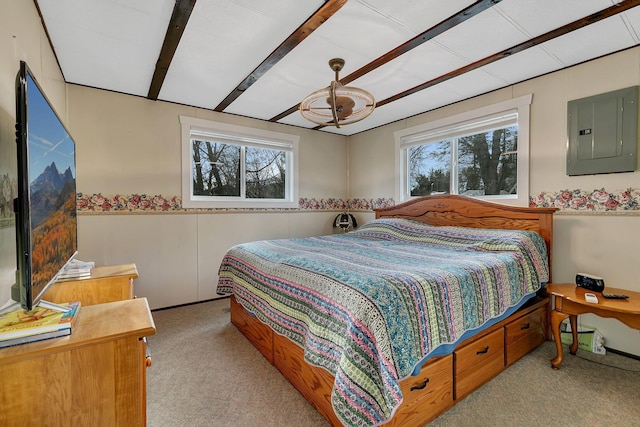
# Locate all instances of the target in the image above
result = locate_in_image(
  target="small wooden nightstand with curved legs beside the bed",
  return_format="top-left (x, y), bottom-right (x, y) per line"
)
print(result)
top-left (547, 283), bottom-right (640, 369)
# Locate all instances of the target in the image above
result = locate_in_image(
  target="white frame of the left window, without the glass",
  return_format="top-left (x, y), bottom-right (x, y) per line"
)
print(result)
top-left (180, 116), bottom-right (300, 209)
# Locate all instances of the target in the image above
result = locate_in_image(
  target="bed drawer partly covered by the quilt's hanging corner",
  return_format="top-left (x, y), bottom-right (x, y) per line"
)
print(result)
top-left (390, 354), bottom-right (453, 426)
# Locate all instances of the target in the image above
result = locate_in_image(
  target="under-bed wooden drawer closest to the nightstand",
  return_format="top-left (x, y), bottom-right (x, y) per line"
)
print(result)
top-left (505, 306), bottom-right (547, 366)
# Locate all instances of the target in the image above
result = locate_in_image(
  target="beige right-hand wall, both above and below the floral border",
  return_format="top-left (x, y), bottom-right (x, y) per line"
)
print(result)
top-left (349, 47), bottom-right (640, 355)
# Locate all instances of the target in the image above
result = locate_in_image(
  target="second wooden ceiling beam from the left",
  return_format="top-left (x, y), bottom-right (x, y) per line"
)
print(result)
top-left (214, 0), bottom-right (347, 112)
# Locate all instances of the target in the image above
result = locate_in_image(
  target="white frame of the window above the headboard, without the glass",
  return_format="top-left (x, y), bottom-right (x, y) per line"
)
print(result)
top-left (394, 94), bottom-right (533, 206)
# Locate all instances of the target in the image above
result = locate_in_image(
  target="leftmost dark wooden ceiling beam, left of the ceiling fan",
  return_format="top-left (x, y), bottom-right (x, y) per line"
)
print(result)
top-left (147, 0), bottom-right (196, 101)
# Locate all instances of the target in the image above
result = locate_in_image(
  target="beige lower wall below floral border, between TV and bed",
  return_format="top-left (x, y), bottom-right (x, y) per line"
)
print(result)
top-left (78, 212), bottom-right (342, 308)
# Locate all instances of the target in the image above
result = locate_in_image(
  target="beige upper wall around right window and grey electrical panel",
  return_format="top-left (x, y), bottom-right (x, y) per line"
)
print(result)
top-left (349, 47), bottom-right (640, 198)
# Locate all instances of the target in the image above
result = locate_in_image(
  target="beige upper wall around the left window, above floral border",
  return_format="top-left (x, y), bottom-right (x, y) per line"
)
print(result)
top-left (68, 85), bottom-right (347, 198)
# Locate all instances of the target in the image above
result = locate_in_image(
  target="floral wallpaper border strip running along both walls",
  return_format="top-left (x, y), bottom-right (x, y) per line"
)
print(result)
top-left (77, 188), bottom-right (640, 216)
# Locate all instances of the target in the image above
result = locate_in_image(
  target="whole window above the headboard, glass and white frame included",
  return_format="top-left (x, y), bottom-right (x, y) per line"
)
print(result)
top-left (395, 95), bottom-right (531, 206)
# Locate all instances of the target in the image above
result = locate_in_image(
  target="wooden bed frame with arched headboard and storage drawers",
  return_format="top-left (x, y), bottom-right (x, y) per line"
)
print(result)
top-left (231, 195), bottom-right (556, 426)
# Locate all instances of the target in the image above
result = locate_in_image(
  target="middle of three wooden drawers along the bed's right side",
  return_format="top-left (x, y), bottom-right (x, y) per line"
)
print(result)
top-left (453, 328), bottom-right (505, 400)
